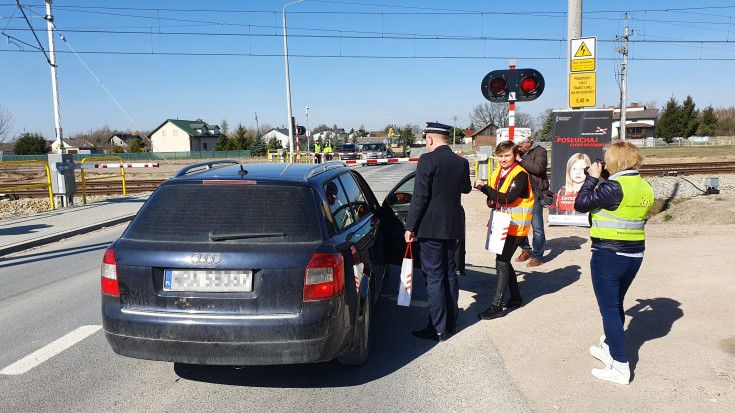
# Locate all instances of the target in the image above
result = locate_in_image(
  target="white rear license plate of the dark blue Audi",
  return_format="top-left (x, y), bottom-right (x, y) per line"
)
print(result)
top-left (163, 270), bottom-right (253, 293)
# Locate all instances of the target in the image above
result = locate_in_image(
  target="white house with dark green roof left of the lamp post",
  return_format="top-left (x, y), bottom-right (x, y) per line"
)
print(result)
top-left (150, 119), bottom-right (225, 152)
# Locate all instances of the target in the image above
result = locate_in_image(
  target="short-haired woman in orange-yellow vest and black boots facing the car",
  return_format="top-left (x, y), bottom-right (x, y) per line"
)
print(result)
top-left (475, 141), bottom-right (534, 320)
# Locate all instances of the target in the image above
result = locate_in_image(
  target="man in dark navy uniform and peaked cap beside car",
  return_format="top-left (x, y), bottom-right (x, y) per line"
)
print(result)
top-left (405, 122), bottom-right (472, 341)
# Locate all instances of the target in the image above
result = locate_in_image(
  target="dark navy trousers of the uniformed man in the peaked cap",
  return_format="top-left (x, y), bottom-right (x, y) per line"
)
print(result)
top-left (419, 239), bottom-right (459, 333)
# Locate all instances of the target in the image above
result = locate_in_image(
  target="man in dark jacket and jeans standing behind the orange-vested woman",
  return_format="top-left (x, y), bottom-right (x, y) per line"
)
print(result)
top-left (513, 136), bottom-right (549, 267)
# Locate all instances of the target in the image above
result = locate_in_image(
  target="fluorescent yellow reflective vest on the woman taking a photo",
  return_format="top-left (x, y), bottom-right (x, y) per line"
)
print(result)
top-left (590, 171), bottom-right (653, 241)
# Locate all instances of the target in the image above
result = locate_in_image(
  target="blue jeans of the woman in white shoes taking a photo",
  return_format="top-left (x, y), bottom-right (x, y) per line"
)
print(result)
top-left (590, 250), bottom-right (643, 363)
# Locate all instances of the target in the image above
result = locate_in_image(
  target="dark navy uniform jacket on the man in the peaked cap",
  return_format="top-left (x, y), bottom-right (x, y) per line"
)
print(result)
top-left (406, 145), bottom-right (472, 239)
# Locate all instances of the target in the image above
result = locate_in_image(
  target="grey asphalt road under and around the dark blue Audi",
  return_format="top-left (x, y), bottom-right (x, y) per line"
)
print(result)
top-left (0, 160), bottom-right (530, 412)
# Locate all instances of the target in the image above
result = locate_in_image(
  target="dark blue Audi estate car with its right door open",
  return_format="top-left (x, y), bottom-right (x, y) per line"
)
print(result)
top-left (102, 161), bottom-right (413, 365)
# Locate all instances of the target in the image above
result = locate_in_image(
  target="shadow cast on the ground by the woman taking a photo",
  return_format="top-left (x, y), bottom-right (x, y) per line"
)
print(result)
top-left (625, 297), bottom-right (684, 371)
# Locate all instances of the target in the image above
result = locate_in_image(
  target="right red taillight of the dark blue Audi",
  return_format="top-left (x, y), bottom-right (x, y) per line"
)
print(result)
top-left (304, 254), bottom-right (345, 301)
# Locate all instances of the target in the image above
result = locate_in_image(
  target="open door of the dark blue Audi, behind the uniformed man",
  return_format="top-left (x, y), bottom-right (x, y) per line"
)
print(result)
top-left (380, 172), bottom-right (466, 274)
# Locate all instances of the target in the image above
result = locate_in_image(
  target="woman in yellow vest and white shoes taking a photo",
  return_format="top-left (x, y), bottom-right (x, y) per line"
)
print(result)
top-left (574, 141), bottom-right (653, 384)
